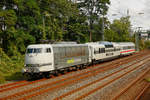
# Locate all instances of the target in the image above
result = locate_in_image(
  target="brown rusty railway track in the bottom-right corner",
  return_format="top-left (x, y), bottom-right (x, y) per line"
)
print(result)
top-left (112, 70), bottom-right (150, 100)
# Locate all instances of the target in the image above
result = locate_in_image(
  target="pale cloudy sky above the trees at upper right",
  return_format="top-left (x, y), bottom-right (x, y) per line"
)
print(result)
top-left (107, 0), bottom-right (150, 30)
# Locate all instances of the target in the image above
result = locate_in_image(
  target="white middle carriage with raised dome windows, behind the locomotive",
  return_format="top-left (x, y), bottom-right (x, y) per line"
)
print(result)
top-left (86, 42), bottom-right (120, 62)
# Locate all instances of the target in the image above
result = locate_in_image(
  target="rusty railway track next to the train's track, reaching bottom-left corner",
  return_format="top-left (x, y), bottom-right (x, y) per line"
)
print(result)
top-left (0, 50), bottom-right (147, 99)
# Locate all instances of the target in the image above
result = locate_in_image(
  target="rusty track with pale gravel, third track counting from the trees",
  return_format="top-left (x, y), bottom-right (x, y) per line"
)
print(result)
top-left (54, 56), bottom-right (150, 100)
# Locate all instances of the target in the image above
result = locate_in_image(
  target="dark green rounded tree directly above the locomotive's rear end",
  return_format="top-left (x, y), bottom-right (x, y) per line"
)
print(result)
top-left (64, 14), bottom-right (89, 43)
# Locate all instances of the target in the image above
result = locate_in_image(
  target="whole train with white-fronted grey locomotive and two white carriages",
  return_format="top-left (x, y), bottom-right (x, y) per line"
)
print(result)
top-left (22, 42), bottom-right (135, 78)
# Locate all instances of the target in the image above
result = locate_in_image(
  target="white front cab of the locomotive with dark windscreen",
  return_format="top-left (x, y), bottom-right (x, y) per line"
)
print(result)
top-left (22, 44), bottom-right (54, 74)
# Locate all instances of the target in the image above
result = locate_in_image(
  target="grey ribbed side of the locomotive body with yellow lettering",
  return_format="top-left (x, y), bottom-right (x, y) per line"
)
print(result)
top-left (52, 44), bottom-right (89, 69)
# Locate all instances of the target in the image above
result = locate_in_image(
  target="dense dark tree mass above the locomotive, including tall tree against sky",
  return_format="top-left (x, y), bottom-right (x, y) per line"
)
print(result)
top-left (0, 0), bottom-right (110, 56)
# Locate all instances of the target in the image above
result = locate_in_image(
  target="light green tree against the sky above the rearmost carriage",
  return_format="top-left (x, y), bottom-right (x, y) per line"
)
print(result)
top-left (105, 16), bottom-right (132, 42)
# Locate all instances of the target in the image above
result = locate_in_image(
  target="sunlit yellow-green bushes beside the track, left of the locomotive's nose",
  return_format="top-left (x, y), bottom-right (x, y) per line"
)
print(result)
top-left (0, 48), bottom-right (24, 83)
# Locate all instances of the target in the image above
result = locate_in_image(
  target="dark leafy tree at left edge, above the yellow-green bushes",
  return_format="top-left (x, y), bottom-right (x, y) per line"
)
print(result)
top-left (0, 0), bottom-right (36, 56)
